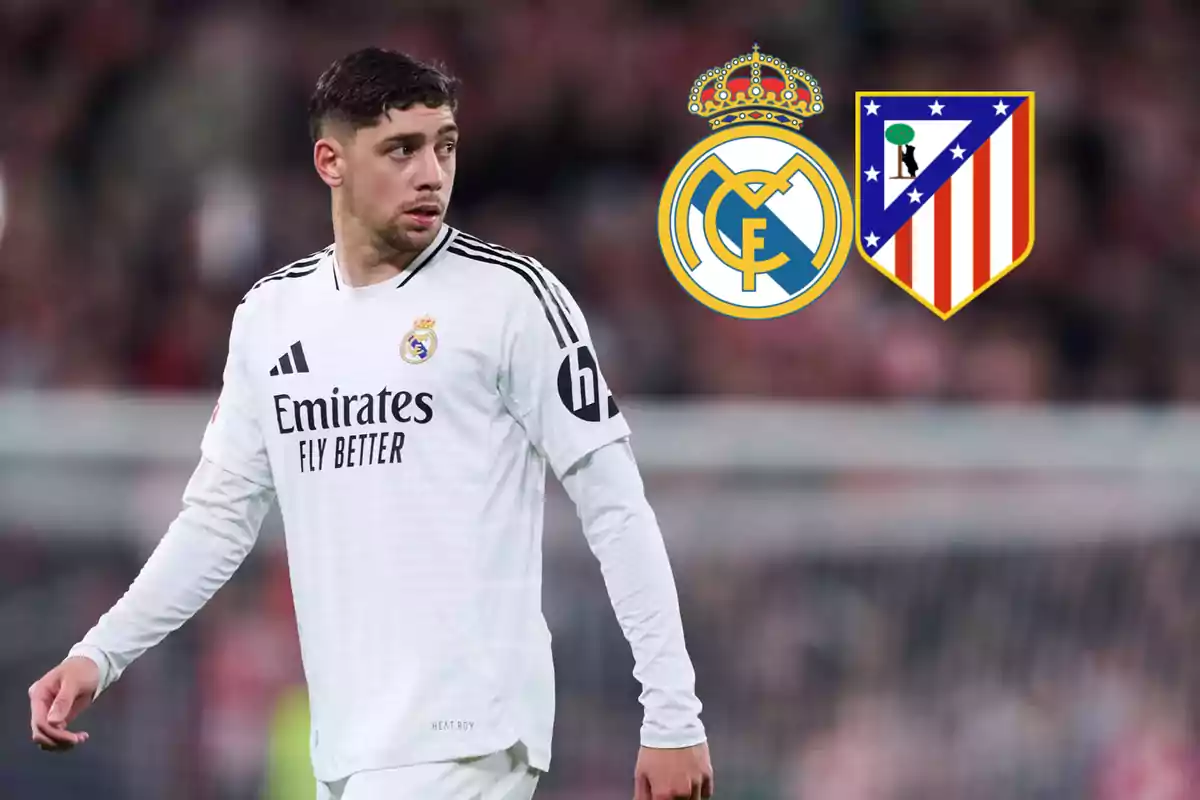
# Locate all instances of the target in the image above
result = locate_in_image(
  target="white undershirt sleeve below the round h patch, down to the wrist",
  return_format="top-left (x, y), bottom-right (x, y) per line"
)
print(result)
top-left (562, 439), bottom-right (706, 747)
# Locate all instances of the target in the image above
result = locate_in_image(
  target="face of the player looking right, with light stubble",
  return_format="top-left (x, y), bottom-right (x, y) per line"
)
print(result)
top-left (343, 103), bottom-right (458, 252)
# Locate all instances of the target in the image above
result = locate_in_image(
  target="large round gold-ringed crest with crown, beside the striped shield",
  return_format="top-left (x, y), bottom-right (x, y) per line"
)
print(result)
top-left (659, 44), bottom-right (854, 319)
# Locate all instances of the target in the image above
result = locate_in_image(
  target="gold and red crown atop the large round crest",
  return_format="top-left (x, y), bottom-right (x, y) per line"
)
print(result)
top-left (688, 44), bottom-right (824, 131)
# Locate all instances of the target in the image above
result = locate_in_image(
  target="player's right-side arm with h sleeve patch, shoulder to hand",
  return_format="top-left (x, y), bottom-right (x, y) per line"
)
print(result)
top-left (499, 257), bottom-right (713, 800)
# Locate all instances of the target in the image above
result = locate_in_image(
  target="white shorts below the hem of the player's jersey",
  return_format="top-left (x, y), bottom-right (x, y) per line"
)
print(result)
top-left (317, 745), bottom-right (541, 800)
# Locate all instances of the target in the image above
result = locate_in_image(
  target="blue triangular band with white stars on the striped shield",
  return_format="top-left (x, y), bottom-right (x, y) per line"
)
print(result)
top-left (854, 95), bottom-right (1028, 255)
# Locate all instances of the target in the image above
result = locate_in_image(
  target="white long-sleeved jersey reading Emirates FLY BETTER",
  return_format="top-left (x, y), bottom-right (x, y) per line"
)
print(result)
top-left (65, 225), bottom-right (703, 780)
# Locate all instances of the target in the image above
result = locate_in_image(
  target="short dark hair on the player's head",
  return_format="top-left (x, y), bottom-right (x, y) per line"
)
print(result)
top-left (308, 47), bottom-right (458, 142)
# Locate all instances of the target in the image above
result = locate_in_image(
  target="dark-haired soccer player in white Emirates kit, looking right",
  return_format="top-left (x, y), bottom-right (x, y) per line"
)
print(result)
top-left (29, 48), bottom-right (713, 800)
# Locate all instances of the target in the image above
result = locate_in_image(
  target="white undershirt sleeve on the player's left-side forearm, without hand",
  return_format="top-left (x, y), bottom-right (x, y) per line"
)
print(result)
top-left (68, 458), bottom-right (275, 697)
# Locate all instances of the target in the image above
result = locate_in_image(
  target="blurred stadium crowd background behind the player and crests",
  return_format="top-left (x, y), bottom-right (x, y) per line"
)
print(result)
top-left (0, 0), bottom-right (1200, 800)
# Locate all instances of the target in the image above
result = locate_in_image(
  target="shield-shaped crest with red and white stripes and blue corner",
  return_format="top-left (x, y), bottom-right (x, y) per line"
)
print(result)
top-left (854, 91), bottom-right (1033, 319)
